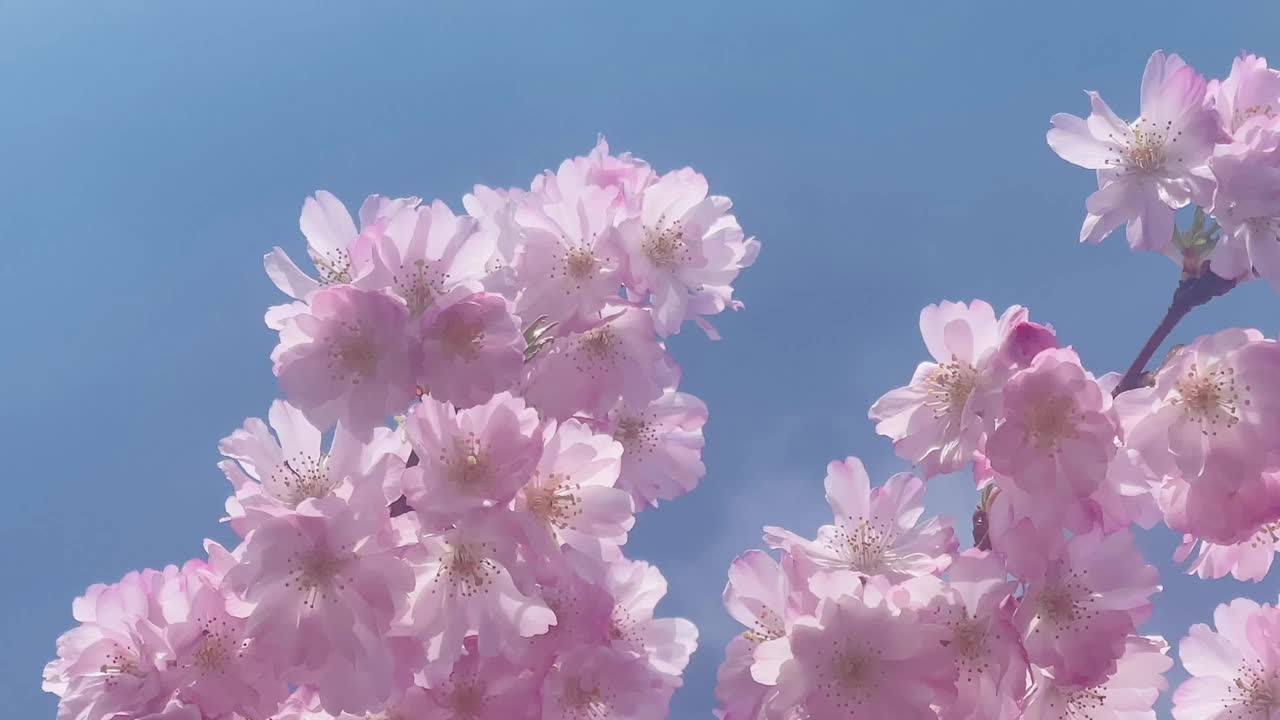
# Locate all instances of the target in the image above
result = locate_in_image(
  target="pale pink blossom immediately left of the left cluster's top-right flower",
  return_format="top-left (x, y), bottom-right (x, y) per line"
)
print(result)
top-left (516, 177), bottom-right (622, 329)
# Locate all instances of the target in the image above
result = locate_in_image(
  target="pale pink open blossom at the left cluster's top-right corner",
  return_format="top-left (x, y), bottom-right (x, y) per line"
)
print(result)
top-left (620, 168), bottom-right (760, 337)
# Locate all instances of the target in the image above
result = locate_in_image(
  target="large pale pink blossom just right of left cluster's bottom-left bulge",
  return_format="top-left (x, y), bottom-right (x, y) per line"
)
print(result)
top-left (225, 502), bottom-right (413, 712)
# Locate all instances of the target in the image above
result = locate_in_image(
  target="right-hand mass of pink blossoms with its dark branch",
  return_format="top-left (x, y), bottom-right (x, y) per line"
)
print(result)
top-left (718, 53), bottom-right (1280, 720)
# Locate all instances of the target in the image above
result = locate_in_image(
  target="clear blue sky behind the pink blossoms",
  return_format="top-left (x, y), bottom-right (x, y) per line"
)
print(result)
top-left (0, 0), bottom-right (1280, 719)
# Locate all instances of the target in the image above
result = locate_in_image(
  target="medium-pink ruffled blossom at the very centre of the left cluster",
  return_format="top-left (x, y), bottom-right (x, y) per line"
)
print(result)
top-left (402, 392), bottom-right (543, 529)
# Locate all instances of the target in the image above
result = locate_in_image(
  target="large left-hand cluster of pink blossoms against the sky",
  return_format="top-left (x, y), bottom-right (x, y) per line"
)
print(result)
top-left (44, 141), bottom-right (759, 720)
